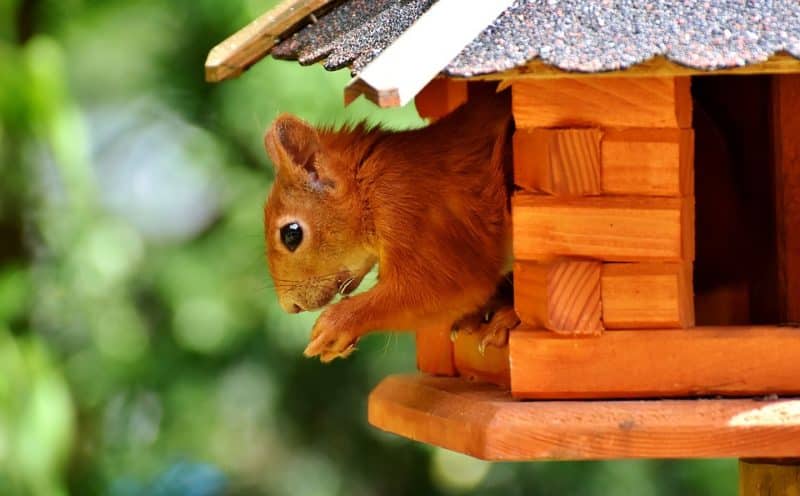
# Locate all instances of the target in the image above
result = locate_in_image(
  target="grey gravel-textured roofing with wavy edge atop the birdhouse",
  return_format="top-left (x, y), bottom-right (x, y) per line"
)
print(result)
top-left (272, 0), bottom-right (800, 77)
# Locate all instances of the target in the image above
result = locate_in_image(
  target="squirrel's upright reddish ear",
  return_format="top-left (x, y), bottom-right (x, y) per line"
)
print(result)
top-left (264, 114), bottom-right (320, 188)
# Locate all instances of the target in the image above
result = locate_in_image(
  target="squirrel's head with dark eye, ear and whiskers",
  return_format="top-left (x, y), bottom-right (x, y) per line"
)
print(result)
top-left (264, 114), bottom-right (376, 313)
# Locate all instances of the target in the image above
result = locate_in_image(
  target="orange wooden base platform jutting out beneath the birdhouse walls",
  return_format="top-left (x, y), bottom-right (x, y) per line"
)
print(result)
top-left (368, 376), bottom-right (800, 461)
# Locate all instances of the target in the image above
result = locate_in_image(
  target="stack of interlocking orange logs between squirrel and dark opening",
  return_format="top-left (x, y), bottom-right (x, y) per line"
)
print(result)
top-left (511, 78), bottom-right (694, 335)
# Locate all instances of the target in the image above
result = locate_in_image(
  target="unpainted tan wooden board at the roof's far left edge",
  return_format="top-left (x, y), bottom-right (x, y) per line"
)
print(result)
top-left (206, 0), bottom-right (331, 82)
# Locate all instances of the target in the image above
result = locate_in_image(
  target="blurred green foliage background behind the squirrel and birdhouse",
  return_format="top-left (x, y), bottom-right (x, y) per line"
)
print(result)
top-left (0, 0), bottom-right (736, 496)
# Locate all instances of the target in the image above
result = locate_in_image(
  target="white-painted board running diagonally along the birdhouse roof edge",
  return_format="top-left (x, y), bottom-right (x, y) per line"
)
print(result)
top-left (345, 0), bottom-right (514, 107)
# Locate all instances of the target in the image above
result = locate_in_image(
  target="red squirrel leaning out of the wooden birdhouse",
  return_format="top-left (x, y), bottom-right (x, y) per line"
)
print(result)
top-left (264, 92), bottom-right (518, 362)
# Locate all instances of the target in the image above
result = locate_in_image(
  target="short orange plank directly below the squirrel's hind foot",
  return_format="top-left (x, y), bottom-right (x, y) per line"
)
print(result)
top-left (453, 332), bottom-right (511, 388)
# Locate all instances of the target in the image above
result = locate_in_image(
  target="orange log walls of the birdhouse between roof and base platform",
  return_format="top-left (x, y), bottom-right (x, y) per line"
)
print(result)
top-left (418, 77), bottom-right (800, 398)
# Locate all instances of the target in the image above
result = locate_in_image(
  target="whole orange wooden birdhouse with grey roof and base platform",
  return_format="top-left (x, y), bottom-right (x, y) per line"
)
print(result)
top-left (207, 0), bottom-right (800, 488)
